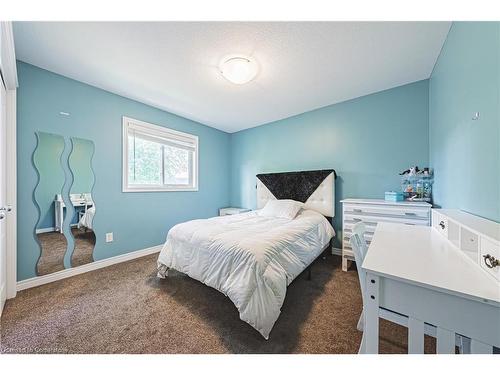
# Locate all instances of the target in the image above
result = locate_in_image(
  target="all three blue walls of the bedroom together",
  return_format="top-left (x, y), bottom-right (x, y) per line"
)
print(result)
top-left (17, 22), bottom-right (500, 280)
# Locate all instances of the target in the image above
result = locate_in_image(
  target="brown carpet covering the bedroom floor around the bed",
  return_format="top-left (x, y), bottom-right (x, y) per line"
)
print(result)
top-left (0, 254), bottom-right (435, 353)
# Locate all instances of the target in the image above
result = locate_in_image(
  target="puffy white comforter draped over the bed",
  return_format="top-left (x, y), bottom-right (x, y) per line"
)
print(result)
top-left (158, 210), bottom-right (335, 339)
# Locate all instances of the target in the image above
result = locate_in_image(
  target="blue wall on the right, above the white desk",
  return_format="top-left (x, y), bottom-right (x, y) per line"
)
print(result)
top-left (429, 22), bottom-right (500, 222)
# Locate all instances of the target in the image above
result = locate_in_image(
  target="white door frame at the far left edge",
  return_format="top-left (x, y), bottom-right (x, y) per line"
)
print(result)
top-left (0, 21), bottom-right (18, 299)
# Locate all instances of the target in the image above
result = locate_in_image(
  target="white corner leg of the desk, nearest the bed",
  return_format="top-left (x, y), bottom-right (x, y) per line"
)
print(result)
top-left (364, 272), bottom-right (380, 354)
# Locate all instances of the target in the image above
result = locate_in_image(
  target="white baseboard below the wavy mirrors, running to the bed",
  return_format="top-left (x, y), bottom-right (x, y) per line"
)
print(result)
top-left (17, 245), bottom-right (163, 292)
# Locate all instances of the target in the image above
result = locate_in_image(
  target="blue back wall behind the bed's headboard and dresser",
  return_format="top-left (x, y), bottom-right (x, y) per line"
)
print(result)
top-left (231, 80), bottom-right (429, 246)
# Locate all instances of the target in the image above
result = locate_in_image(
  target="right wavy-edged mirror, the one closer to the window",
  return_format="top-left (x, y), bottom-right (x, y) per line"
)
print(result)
top-left (68, 138), bottom-right (96, 267)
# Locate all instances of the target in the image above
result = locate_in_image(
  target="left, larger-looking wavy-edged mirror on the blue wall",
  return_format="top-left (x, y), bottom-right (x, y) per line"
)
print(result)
top-left (33, 132), bottom-right (67, 276)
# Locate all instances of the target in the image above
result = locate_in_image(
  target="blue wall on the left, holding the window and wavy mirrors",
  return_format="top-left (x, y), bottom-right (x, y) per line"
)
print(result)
top-left (17, 62), bottom-right (229, 280)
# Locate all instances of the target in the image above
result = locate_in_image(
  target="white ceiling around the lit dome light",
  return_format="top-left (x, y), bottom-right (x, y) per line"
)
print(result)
top-left (14, 22), bottom-right (450, 132)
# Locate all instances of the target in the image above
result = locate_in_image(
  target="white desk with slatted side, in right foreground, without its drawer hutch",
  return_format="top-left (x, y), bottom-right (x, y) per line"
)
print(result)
top-left (362, 223), bottom-right (500, 353)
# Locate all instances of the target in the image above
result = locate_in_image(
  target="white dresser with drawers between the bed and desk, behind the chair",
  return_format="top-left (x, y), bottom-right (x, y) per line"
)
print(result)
top-left (340, 199), bottom-right (432, 271)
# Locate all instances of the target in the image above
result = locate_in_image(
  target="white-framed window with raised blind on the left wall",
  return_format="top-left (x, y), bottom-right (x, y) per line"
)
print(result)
top-left (123, 117), bottom-right (198, 192)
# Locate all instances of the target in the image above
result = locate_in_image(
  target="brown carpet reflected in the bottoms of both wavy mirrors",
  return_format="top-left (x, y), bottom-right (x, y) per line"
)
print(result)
top-left (37, 228), bottom-right (95, 276)
